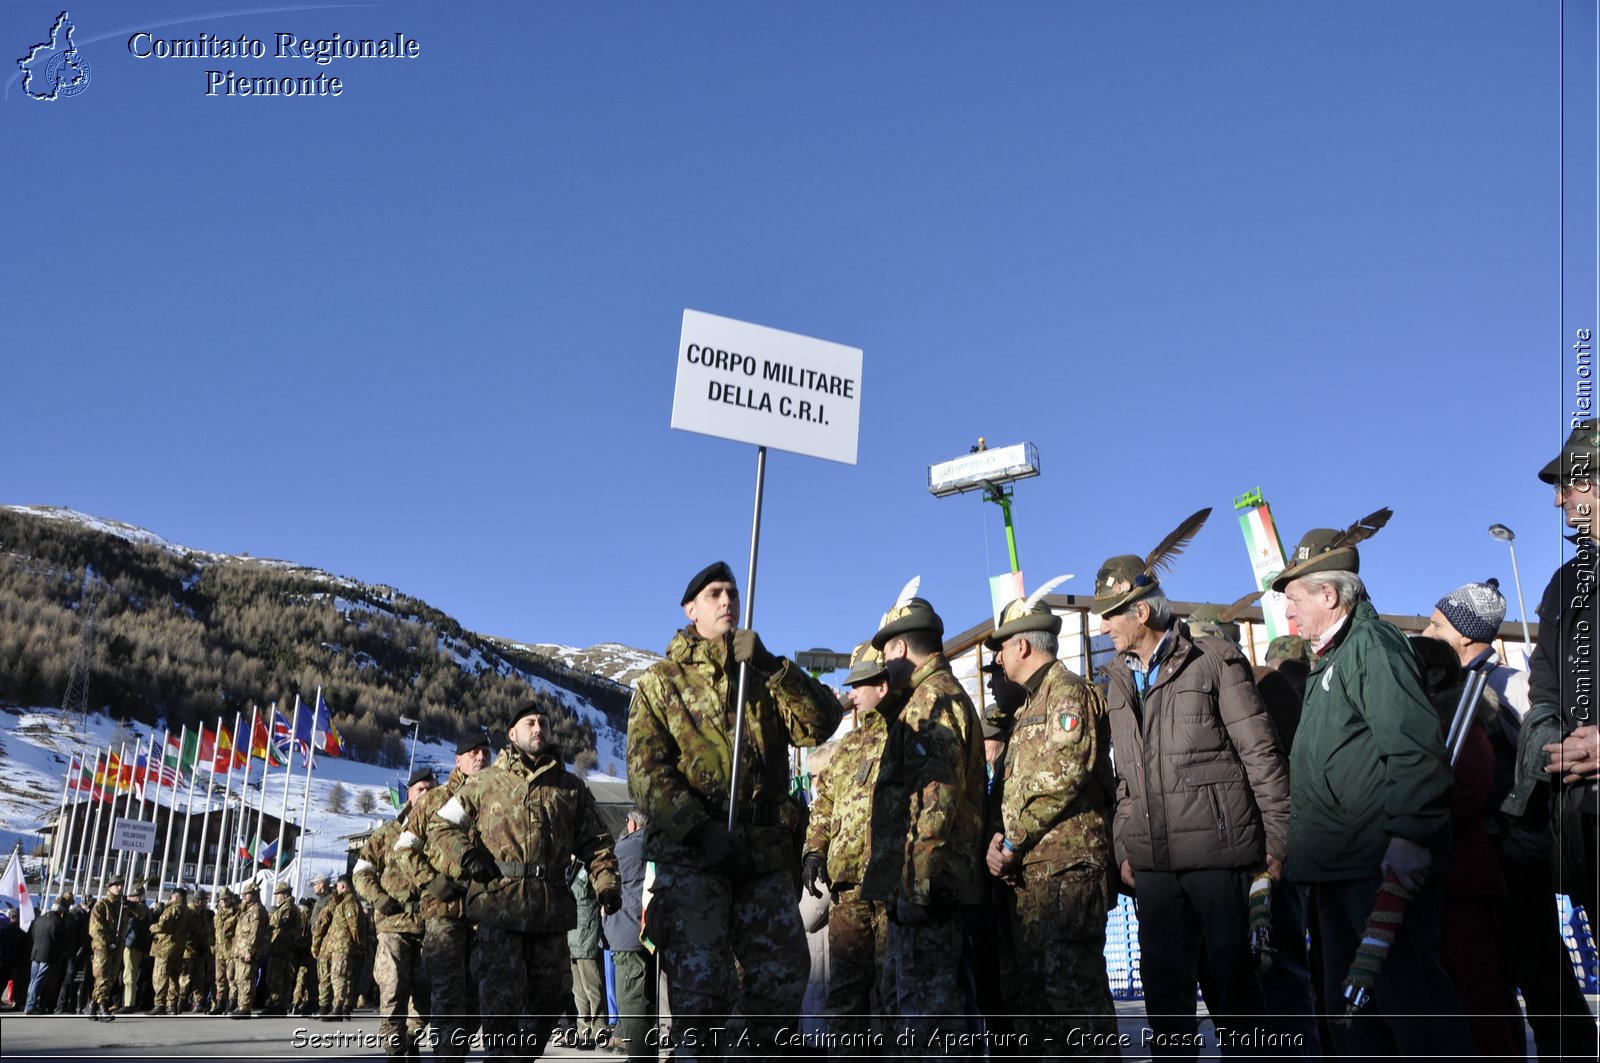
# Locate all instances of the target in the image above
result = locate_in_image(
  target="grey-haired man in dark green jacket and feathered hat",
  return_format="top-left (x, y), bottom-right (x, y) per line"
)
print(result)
top-left (1272, 514), bottom-right (1474, 1058)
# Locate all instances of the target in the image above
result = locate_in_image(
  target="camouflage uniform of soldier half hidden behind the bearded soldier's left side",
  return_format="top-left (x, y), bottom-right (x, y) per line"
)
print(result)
top-left (394, 772), bottom-right (478, 1060)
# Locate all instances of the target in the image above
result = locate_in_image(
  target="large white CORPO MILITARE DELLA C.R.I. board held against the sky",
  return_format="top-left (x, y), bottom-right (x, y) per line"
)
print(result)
top-left (672, 311), bottom-right (861, 464)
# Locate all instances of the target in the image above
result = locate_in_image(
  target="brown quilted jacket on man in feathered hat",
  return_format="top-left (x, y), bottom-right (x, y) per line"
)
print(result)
top-left (1107, 623), bottom-right (1290, 871)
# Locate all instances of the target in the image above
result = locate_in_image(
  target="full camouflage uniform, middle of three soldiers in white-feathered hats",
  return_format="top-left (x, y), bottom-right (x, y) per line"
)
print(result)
top-left (861, 653), bottom-right (987, 1055)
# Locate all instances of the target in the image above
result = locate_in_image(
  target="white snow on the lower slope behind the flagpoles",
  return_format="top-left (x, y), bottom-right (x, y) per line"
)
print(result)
top-left (0, 704), bottom-right (624, 892)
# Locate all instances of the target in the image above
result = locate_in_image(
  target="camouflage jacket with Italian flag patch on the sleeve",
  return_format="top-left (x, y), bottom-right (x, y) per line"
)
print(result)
top-left (989, 661), bottom-right (1117, 869)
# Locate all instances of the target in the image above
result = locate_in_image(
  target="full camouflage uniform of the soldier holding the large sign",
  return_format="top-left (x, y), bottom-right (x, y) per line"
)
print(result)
top-left (627, 624), bottom-right (840, 1060)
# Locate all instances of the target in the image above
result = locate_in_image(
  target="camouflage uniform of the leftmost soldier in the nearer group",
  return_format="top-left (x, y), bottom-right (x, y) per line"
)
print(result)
top-left (350, 808), bottom-right (429, 1060)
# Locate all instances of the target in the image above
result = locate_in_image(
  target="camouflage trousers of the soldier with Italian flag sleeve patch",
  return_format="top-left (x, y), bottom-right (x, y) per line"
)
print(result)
top-left (1000, 864), bottom-right (1120, 1060)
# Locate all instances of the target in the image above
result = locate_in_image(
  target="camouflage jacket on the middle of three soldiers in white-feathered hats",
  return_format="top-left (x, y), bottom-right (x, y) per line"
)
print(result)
top-left (861, 653), bottom-right (989, 914)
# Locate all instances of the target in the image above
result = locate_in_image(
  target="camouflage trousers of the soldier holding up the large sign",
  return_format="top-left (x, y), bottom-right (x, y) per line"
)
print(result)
top-left (646, 864), bottom-right (811, 1060)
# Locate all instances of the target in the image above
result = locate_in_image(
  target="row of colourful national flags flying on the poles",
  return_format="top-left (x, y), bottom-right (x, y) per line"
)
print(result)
top-left (67, 692), bottom-right (344, 800)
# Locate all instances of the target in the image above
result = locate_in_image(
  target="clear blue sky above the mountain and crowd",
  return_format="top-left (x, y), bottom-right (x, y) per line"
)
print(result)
top-left (0, 0), bottom-right (1597, 672)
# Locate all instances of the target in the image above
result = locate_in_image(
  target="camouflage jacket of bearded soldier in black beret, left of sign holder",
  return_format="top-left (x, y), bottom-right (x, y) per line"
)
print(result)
top-left (430, 746), bottom-right (618, 933)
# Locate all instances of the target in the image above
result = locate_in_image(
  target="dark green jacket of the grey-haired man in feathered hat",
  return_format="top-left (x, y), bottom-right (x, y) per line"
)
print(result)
top-left (1288, 602), bottom-right (1451, 882)
